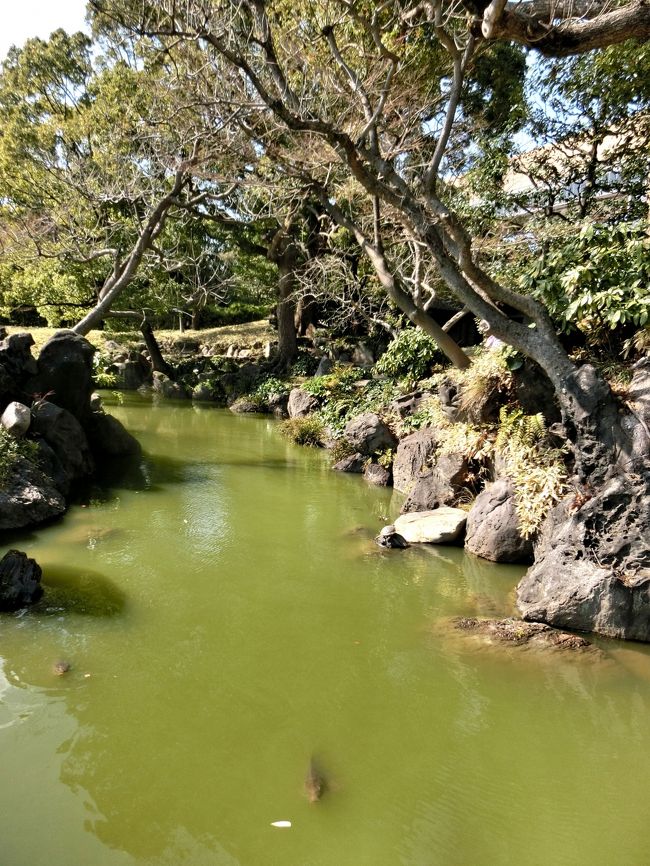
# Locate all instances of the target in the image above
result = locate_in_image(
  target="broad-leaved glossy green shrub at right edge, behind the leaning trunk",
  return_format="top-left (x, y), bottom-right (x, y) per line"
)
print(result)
top-left (522, 223), bottom-right (650, 343)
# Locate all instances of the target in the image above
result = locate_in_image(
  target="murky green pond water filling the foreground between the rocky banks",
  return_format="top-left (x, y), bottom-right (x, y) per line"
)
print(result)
top-left (0, 397), bottom-right (650, 866)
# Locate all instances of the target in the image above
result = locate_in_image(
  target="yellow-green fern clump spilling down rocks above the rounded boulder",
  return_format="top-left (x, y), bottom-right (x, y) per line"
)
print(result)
top-left (495, 407), bottom-right (568, 538)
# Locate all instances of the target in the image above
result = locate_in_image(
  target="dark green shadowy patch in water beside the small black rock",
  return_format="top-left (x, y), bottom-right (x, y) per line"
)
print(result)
top-left (28, 565), bottom-right (126, 617)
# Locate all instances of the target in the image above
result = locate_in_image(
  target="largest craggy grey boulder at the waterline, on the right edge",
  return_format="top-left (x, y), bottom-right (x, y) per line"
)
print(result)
top-left (517, 469), bottom-right (650, 641)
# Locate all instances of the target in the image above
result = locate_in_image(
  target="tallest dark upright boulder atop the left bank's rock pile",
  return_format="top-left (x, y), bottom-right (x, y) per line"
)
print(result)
top-left (30, 331), bottom-right (95, 424)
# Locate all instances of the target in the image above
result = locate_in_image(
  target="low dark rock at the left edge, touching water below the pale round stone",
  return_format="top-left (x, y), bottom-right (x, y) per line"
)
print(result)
top-left (0, 458), bottom-right (65, 529)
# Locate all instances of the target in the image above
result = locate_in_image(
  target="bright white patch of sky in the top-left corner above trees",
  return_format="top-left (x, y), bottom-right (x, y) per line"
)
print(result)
top-left (0, 0), bottom-right (86, 61)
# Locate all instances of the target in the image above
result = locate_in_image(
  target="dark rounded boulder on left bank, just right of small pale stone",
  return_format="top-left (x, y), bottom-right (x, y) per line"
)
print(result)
top-left (32, 400), bottom-right (95, 481)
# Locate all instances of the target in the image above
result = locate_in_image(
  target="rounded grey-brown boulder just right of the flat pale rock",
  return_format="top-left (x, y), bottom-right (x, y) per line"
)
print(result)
top-left (465, 479), bottom-right (533, 562)
